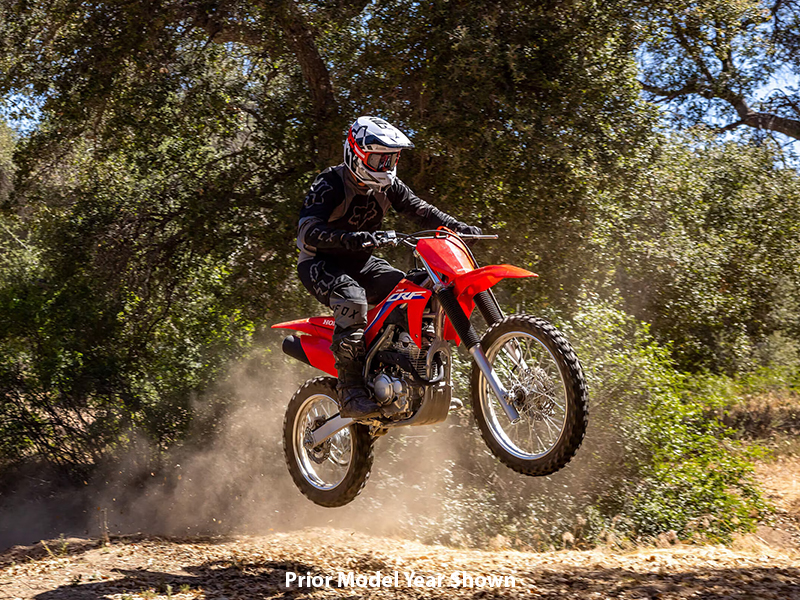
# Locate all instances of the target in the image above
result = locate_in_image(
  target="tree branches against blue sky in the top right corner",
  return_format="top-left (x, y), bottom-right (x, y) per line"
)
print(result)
top-left (641, 0), bottom-right (800, 139)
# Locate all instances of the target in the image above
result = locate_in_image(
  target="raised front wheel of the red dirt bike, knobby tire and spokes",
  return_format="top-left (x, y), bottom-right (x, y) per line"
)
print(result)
top-left (472, 315), bottom-right (589, 475)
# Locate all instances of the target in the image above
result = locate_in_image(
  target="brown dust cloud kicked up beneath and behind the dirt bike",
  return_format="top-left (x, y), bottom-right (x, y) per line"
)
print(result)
top-left (0, 342), bottom-right (608, 548)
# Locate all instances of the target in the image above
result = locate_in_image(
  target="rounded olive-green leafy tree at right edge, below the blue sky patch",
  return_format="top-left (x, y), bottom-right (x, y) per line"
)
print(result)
top-left (595, 134), bottom-right (800, 373)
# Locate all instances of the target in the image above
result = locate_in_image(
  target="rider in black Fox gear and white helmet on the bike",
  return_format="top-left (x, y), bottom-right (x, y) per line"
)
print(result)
top-left (297, 117), bottom-right (481, 419)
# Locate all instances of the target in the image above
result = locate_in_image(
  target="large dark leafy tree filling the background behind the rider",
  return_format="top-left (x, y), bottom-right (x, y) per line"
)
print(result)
top-left (0, 0), bottom-right (651, 464)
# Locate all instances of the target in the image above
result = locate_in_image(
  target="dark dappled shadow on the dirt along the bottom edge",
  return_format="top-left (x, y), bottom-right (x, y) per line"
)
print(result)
top-left (35, 561), bottom-right (800, 600)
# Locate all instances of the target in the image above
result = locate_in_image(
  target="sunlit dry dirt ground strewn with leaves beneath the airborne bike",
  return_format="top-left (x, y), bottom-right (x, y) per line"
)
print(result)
top-left (0, 458), bottom-right (800, 600)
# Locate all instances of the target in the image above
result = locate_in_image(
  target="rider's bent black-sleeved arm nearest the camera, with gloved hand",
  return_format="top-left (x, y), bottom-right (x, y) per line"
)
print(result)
top-left (297, 171), bottom-right (374, 252)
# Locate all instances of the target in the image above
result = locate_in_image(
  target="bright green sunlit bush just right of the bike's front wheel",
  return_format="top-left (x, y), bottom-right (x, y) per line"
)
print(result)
top-left (574, 300), bottom-right (763, 539)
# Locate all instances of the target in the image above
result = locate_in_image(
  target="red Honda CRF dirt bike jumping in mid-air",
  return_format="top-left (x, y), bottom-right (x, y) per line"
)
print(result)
top-left (273, 228), bottom-right (588, 507)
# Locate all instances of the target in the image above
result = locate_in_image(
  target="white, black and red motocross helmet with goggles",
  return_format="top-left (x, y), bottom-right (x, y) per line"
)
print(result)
top-left (344, 117), bottom-right (414, 192)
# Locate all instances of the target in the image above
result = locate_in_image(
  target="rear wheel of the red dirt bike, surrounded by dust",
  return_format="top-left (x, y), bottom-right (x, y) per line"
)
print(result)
top-left (283, 377), bottom-right (373, 507)
